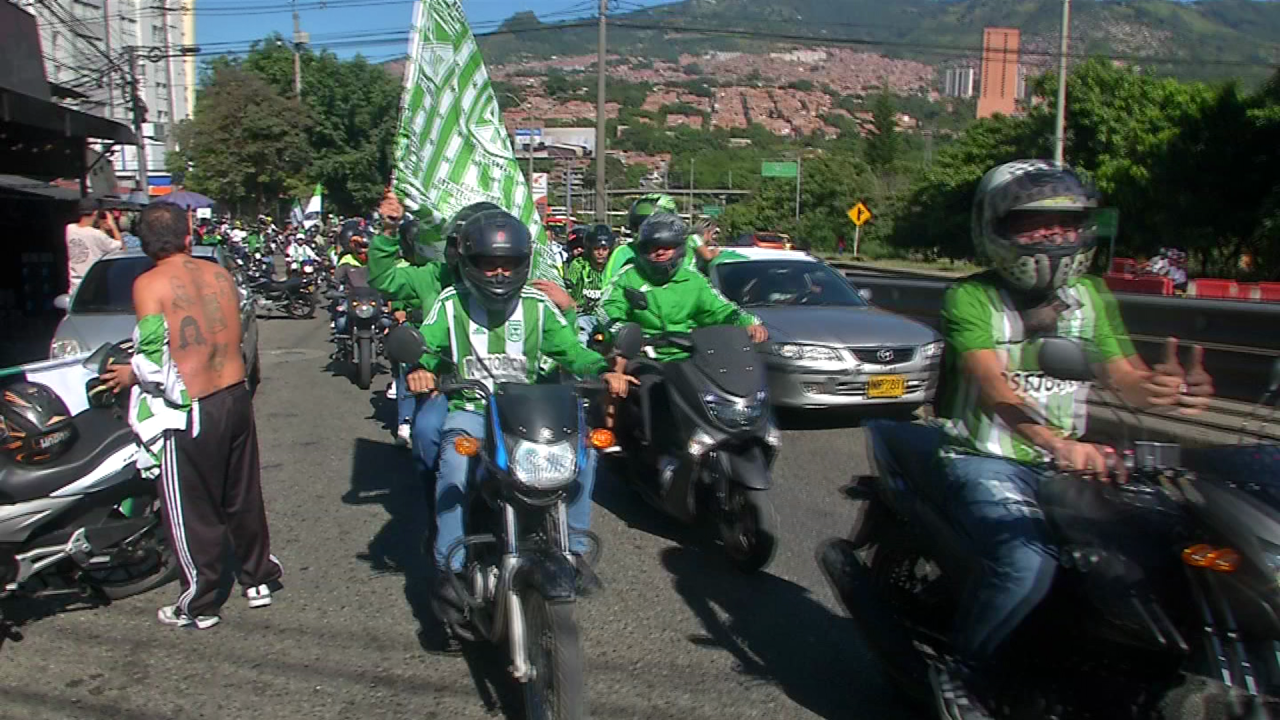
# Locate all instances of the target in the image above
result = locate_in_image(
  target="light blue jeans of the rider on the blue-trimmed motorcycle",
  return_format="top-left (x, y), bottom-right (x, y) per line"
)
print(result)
top-left (435, 410), bottom-right (596, 573)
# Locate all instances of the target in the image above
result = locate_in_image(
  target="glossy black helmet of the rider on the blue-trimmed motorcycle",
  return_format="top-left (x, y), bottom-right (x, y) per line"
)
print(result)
top-left (458, 210), bottom-right (534, 313)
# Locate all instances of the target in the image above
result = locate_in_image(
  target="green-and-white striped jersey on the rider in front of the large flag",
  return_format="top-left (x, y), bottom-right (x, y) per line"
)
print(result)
top-left (422, 287), bottom-right (608, 413)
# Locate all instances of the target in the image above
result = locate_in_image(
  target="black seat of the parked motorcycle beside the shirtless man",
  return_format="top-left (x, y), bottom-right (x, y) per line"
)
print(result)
top-left (0, 407), bottom-right (134, 505)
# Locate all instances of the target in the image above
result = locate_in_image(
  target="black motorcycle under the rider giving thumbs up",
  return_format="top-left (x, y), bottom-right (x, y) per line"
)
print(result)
top-left (817, 338), bottom-right (1280, 720)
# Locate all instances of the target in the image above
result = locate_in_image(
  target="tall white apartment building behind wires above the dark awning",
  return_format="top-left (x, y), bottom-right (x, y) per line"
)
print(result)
top-left (10, 0), bottom-right (196, 187)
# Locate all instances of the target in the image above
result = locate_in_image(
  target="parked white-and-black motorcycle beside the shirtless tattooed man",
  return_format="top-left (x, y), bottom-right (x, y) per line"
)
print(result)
top-left (0, 343), bottom-right (179, 641)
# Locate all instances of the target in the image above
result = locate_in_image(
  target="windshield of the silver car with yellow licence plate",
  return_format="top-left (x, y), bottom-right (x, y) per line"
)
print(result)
top-left (716, 260), bottom-right (867, 307)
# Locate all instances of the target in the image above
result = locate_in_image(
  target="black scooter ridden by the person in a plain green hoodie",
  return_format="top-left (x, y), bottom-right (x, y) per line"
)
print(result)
top-left (614, 308), bottom-right (782, 573)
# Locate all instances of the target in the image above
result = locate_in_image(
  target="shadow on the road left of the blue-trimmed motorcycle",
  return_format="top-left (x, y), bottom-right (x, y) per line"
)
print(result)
top-left (342, 435), bottom-right (524, 719)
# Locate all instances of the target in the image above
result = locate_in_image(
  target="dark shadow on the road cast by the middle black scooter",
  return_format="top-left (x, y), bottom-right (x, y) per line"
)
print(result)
top-left (662, 547), bottom-right (910, 719)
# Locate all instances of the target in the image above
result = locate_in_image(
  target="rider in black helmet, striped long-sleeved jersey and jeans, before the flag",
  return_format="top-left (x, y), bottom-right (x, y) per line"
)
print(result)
top-left (408, 210), bottom-right (635, 619)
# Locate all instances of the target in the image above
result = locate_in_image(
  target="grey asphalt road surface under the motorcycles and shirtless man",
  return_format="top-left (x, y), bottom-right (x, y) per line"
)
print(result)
top-left (0, 318), bottom-right (910, 720)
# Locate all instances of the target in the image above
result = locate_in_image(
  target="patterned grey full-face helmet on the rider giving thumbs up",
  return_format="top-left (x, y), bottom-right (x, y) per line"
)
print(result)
top-left (972, 160), bottom-right (1098, 293)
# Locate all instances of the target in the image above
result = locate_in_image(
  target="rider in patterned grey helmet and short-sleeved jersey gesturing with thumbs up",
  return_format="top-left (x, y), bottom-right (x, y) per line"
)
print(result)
top-left (869, 160), bottom-right (1213, 720)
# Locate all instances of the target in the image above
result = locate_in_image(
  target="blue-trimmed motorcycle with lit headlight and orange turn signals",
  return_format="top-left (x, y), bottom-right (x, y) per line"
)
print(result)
top-left (387, 325), bottom-right (613, 720)
